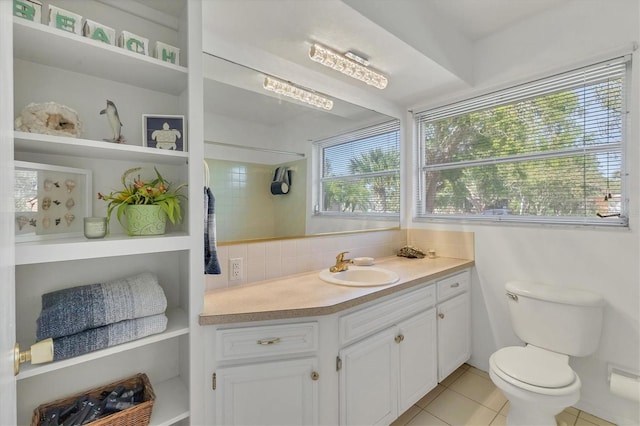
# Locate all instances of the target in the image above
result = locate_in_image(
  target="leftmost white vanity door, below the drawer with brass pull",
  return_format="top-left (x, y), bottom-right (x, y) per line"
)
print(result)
top-left (216, 358), bottom-right (318, 426)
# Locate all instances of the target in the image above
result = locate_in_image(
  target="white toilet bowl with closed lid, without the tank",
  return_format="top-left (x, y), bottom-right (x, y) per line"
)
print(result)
top-left (489, 345), bottom-right (581, 426)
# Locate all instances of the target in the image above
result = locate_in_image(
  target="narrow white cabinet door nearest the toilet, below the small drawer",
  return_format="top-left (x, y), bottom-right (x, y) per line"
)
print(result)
top-left (437, 293), bottom-right (471, 382)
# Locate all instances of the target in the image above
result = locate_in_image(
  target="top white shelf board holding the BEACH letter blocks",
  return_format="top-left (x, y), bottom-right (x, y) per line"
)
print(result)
top-left (13, 17), bottom-right (188, 95)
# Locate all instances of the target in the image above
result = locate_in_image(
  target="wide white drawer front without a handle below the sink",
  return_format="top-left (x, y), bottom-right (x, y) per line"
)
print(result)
top-left (340, 285), bottom-right (436, 345)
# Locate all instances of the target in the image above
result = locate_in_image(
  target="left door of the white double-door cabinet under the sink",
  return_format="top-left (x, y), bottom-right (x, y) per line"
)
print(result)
top-left (340, 327), bottom-right (398, 425)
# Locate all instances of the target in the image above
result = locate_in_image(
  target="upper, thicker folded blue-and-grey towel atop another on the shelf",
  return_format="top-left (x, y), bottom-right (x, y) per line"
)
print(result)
top-left (36, 272), bottom-right (167, 340)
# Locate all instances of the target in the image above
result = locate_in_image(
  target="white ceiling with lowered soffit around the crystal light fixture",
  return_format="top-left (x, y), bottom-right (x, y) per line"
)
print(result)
top-left (202, 0), bottom-right (572, 108)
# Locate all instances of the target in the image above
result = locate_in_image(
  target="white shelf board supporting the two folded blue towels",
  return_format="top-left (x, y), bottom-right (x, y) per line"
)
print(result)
top-left (16, 308), bottom-right (189, 380)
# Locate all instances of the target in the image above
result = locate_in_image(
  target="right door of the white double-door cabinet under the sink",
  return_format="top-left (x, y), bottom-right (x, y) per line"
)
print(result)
top-left (398, 309), bottom-right (438, 413)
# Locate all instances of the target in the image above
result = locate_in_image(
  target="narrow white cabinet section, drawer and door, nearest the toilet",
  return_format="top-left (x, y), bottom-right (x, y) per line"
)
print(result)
top-left (436, 271), bottom-right (471, 382)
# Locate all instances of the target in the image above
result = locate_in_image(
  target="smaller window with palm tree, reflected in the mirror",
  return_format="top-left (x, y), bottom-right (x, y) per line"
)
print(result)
top-left (314, 120), bottom-right (400, 218)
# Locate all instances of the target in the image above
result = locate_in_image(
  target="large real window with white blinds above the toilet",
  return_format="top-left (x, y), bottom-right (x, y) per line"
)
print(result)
top-left (415, 58), bottom-right (628, 225)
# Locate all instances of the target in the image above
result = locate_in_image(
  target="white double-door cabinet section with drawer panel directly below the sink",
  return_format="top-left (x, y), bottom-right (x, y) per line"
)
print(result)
top-left (339, 285), bottom-right (437, 425)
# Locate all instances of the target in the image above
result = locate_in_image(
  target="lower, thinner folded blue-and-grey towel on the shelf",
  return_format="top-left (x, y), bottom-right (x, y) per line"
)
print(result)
top-left (53, 314), bottom-right (167, 361)
